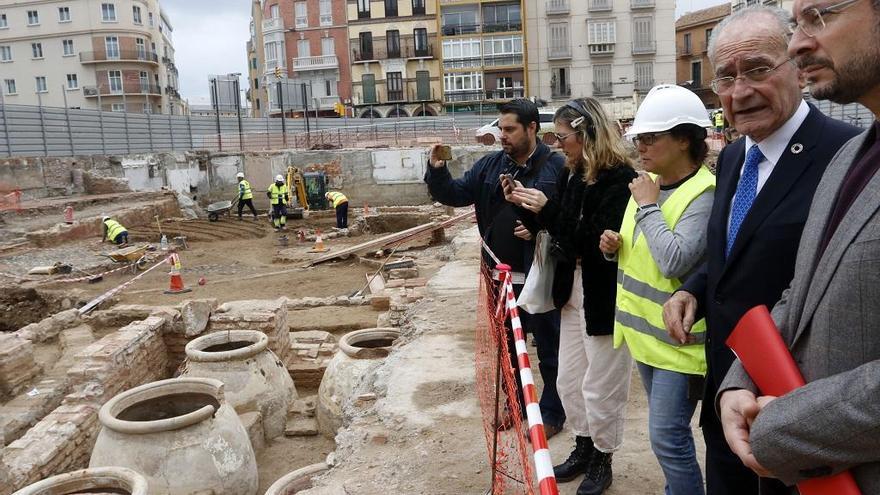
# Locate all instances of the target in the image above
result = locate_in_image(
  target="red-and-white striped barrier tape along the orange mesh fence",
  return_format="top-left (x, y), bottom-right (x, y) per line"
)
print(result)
top-left (495, 263), bottom-right (559, 495)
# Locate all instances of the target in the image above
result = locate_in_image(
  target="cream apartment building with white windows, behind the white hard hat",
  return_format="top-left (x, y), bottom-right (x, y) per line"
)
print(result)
top-left (526, 0), bottom-right (676, 119)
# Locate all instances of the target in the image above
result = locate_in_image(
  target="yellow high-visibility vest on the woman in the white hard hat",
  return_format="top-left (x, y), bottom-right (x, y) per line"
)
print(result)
top-left (614, 167), bottom-right (715, 375)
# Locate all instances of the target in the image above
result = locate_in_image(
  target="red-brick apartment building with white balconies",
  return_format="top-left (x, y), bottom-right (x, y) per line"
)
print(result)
top-left (251, 0), bottom-right (351, 115)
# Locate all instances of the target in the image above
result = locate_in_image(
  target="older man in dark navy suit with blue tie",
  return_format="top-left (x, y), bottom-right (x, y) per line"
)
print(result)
top-left (664, 7), bottom-right (858, 495)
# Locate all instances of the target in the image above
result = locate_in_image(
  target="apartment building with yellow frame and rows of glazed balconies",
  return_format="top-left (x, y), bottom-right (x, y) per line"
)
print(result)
top-left (439, 0), bottom-right (531, 112)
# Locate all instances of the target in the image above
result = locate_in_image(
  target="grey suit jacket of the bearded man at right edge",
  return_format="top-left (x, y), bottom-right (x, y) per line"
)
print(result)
top-left (716, 132), bottom-right (880, 495)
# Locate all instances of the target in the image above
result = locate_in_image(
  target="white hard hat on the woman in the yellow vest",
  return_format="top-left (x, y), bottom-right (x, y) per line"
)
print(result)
top-left (626, 84), bottom-right (712, 137)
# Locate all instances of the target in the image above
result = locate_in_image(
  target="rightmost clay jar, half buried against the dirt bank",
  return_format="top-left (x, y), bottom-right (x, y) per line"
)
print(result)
top-left (315, 328), bottom-right (400, 438)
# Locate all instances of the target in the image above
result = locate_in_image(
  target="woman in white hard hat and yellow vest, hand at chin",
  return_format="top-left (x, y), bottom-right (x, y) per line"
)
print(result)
top-left (599, 85), bottom-right (715, 495)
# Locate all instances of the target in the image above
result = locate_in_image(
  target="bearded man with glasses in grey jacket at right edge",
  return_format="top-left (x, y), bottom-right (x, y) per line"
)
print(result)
top-left (718, 0), bottom-right (880, 495)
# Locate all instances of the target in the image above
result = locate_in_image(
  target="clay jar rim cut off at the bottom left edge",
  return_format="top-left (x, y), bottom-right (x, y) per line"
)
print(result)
top-left (12, 467), bottom-right (148, 495)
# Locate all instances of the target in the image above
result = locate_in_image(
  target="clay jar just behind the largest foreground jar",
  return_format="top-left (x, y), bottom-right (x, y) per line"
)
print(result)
top-left (182, 330), bottom-right (297, 438)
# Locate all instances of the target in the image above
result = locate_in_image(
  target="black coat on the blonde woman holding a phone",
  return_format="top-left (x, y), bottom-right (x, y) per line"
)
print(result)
top-left (538, 165), bottom-right (638, 335)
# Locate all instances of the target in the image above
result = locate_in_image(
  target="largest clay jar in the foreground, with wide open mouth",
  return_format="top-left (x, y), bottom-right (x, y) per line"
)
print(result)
top-left (89, 378), bottom-right (258, 495)
